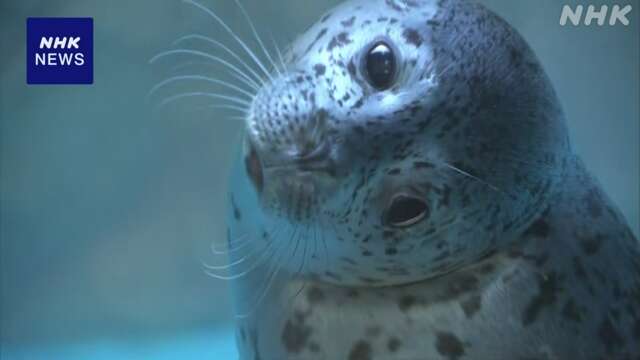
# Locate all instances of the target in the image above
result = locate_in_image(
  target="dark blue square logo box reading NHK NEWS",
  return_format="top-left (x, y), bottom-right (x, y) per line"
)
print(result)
top-left (27, 18), bottom-right (93, 84)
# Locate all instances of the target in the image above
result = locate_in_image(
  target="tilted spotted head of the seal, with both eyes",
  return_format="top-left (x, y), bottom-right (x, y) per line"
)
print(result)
top-left (240, 0), bottom-right (570, 286)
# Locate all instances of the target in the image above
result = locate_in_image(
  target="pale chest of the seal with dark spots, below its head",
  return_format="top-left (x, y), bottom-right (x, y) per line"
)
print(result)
top-left (238, 256), bottom-right (532, 360)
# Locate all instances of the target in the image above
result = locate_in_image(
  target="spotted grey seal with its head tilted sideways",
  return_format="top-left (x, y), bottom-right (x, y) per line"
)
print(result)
top-left (213, 0), bottom-right (640, 360)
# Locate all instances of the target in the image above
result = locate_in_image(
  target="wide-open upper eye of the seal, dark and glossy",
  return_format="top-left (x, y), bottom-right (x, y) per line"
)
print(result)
top-left (364, 42), bottom-right (396, 90)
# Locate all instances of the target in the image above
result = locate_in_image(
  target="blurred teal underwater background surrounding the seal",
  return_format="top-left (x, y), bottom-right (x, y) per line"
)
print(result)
top-left (0, 0), bottom-right (640, 360)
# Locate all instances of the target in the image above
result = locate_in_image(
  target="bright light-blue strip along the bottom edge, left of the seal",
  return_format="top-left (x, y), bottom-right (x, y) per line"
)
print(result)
top-left (0, 329), bottom-right (238, 360)
